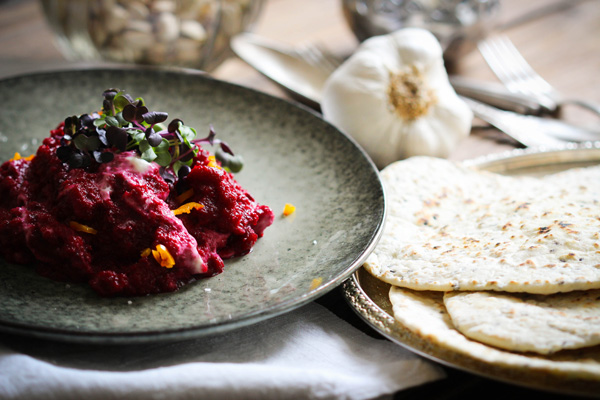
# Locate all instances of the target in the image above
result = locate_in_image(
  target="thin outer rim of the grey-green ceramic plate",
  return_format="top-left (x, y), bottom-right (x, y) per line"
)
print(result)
top-left (0, 63), bottom-right (387, 344)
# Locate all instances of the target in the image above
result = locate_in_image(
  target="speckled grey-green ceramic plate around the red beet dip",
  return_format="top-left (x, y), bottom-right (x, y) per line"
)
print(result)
top-left (0, 68), bottom-right (385, 343)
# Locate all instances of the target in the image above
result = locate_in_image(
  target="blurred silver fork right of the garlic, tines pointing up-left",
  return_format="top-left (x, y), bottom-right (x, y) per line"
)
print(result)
top-left (478, 35), bottom-right (600, 116)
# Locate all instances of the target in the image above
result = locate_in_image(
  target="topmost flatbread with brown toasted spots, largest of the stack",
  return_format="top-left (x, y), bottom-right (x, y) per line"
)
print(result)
top-left (365, 157), bottom-right (600, 294)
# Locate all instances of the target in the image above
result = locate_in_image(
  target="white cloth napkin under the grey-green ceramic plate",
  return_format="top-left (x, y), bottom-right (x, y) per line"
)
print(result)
top-left (0, 303), bottom-right (444, 400)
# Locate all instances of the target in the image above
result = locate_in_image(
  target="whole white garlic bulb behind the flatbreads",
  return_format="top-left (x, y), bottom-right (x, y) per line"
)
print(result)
top-left (321, 28), bottom-right (473, 168)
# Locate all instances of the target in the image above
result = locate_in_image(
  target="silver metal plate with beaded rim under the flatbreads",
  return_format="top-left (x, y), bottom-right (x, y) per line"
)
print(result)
top-left (343, 143), bottom-right (600, 395)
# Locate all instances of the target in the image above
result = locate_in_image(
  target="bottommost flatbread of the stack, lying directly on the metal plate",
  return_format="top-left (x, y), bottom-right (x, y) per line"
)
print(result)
top-left (390, 287), bottom-right (600, 382)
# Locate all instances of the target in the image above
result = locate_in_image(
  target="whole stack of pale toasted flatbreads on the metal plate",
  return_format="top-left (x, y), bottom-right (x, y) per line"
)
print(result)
top-left (364, 157), bottom-right (600, 390)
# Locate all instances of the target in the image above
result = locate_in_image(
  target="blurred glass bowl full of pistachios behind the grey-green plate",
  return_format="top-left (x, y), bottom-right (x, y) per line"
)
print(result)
top-left (41, 0), bottom-right (263, 71)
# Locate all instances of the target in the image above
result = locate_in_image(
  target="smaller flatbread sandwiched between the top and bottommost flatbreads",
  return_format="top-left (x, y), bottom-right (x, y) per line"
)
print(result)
top-left (444, 290), bottom-right (600, 354)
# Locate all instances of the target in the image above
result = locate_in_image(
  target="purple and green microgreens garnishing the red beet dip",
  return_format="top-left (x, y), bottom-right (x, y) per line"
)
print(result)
top-left (57, 89), bottom-right (242, 182)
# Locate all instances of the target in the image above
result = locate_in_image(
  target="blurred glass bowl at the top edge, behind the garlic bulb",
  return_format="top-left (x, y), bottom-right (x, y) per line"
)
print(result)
top-left (342, 0), bottom-right (500, 62)
